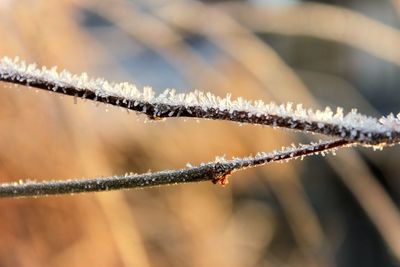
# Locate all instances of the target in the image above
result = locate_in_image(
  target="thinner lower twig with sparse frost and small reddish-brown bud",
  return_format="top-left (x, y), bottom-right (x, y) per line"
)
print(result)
top-left (0, 140), bottom-right (352, 198)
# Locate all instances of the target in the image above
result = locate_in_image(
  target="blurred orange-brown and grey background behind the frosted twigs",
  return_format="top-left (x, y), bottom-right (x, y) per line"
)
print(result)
top-left (0, 0), bottom-right (400, 267)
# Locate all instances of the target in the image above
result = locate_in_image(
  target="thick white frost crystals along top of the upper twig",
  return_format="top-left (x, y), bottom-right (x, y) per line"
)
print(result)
top-left (0, 57), bottom-right (400, 136)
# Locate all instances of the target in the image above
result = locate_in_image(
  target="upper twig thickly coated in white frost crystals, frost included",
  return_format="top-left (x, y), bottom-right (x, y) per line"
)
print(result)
top-left (0, 58), bottom-right (400, 146)
